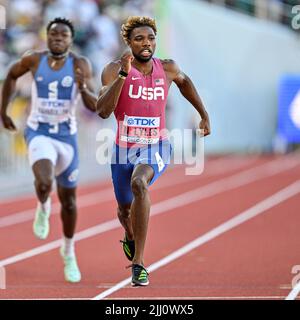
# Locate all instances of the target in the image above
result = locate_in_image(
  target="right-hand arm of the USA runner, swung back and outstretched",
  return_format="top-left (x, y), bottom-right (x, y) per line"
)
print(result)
top-left (164, 60), bottom-right (210, 136)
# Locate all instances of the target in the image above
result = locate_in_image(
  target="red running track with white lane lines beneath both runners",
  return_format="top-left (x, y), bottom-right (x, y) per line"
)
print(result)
top-left (0, 155), bottom-right (300, 300)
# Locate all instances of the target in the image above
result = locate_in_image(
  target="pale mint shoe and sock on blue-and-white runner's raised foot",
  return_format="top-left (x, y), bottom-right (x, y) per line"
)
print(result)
top-left (33, 198), bottom-right (51, 240)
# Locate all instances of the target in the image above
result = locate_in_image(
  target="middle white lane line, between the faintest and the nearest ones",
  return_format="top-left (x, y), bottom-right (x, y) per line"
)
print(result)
top-left (0, 156), bottom-right (298, 266)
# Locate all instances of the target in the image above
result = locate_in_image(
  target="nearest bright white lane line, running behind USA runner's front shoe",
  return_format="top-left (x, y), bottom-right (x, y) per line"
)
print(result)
top-left (92, 180), bottom-right (300, 300)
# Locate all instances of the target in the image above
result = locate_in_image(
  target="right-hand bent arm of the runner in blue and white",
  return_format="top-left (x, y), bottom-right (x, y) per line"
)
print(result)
top-left (75, 57), bottom-right (97, 111)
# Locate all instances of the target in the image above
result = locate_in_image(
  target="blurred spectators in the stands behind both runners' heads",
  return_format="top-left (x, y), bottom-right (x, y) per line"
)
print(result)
top-left (0, 0), bottom-right (154, 80)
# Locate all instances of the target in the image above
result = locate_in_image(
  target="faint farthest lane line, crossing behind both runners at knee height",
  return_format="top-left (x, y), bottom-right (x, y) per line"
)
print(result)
top-left (0, 157), bottom-right (256, 228)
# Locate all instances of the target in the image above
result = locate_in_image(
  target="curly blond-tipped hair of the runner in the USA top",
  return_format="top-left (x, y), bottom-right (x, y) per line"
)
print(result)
top-left (121, 16), bottom-right (157, 44)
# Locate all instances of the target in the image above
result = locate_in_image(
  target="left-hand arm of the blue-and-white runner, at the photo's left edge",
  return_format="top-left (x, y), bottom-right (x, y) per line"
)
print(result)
top-left (0, 54), bottom-right (37, 130)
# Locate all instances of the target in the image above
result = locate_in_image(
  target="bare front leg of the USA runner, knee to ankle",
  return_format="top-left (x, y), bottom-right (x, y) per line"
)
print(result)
top-left (130, 164), bottom-right (154, 265)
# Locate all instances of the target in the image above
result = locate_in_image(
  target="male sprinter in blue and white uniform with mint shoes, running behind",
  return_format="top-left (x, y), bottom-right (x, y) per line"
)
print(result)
top-left (1, 18), bottom-right (97, 282)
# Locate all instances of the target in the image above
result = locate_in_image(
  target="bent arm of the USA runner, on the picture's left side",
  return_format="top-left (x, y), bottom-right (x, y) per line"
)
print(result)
top-left (97, 62), bottom-right (125, 119)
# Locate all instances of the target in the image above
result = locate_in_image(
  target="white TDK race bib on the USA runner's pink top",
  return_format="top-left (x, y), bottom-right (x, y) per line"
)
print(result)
top-left (120, 115), bottom-right (160, 144)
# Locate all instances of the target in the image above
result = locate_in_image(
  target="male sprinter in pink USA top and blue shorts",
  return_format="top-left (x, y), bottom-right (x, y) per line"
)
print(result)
top-left (97, 17), bottom-right (210, 286)
